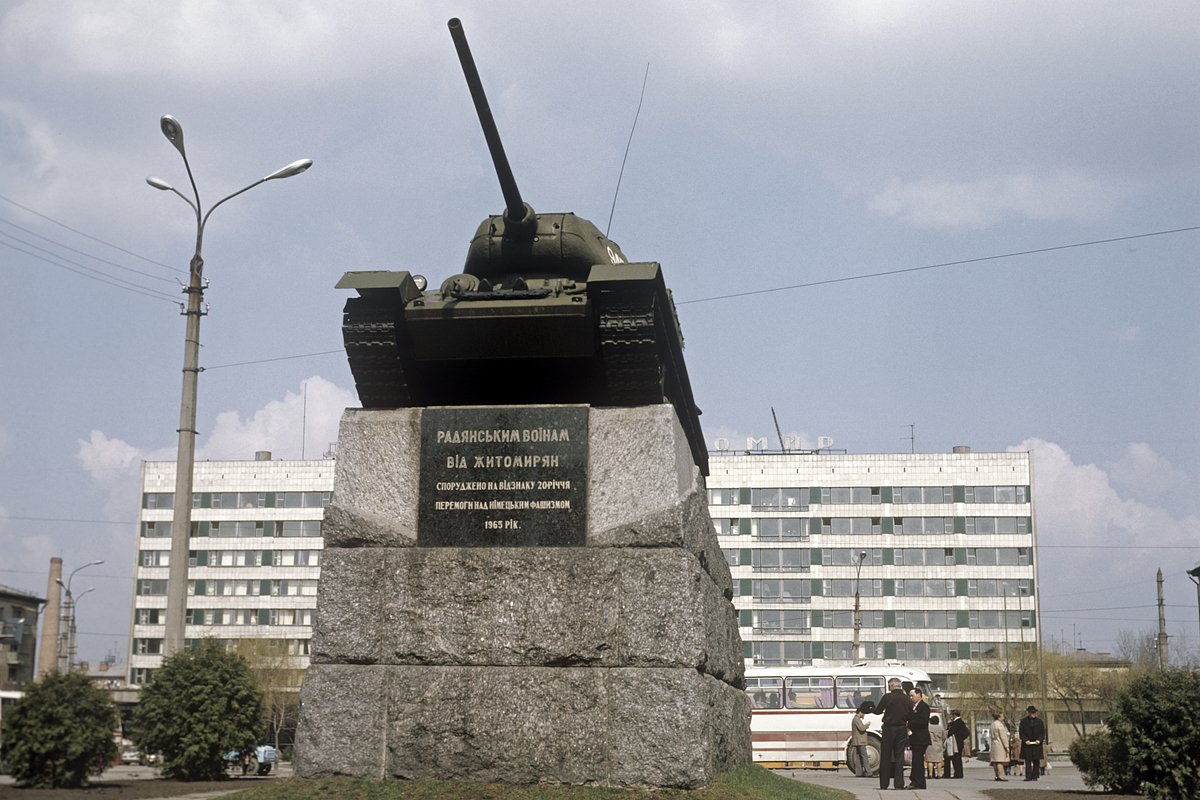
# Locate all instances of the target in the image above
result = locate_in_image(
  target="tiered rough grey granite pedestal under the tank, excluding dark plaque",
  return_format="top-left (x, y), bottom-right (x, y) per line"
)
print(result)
top-left (296, 405), bottom-right (750, 787)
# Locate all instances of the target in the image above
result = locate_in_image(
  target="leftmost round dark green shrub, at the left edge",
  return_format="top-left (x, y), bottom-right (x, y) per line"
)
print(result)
top-left (0, 673), bottom-right (119, 789)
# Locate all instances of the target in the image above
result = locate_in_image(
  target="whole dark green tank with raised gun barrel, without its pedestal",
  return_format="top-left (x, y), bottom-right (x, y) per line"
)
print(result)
top-left (337, 19), bottom-right (708, 475)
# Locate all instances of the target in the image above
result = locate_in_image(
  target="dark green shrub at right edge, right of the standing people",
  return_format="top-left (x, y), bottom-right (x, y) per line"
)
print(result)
top-left (1108, 669), bottom-right (1200, 800)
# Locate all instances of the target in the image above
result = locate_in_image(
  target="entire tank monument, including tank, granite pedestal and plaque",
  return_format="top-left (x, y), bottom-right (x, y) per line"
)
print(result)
top-left (296, 19), bottom-right (750, 787)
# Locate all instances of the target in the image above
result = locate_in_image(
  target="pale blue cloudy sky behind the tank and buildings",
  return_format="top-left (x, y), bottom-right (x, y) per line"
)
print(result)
top-left (0, 0), bottom-right (1200, 662)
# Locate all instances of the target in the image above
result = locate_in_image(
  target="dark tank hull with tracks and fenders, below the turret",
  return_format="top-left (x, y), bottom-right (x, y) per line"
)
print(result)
top-left (338, 263), bottom-right (708, 475)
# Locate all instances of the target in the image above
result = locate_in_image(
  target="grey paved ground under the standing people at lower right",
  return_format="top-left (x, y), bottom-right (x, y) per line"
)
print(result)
top-left (780, 760), bottom-right (1086, 800)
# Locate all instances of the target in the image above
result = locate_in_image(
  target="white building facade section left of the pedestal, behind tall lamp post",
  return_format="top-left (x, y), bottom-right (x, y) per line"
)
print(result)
top-left (130, 453), bottom-right (334, 684)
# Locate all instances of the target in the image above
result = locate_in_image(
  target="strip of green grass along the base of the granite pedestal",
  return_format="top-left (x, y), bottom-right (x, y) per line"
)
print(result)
top-left (229, 765), bottom-right (853, 800)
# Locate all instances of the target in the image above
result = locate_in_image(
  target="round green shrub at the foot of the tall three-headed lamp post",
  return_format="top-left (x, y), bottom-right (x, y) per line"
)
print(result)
top-left (132, 642), bottom-right (262, 781)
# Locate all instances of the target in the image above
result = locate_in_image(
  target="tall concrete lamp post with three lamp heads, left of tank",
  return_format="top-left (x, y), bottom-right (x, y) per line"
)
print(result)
top-left (146, 114), bottom-right (312, 656)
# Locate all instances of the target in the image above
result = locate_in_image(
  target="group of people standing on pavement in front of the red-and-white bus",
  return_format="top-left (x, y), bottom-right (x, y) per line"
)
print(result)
top-left (850, 678), bottom-right (1045, 789)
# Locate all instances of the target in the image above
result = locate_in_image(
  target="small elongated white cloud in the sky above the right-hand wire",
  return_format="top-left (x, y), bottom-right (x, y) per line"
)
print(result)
top-left (868, 172), bottom-right (1138, 229)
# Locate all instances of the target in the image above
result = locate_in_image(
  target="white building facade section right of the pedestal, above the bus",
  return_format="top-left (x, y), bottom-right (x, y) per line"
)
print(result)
top-left (708, 447), bottom-right (1038, 684)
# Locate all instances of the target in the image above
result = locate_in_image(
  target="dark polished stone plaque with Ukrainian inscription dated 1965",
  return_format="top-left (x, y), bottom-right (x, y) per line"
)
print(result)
top-left (416, 405), bottom-right (588, 547)
